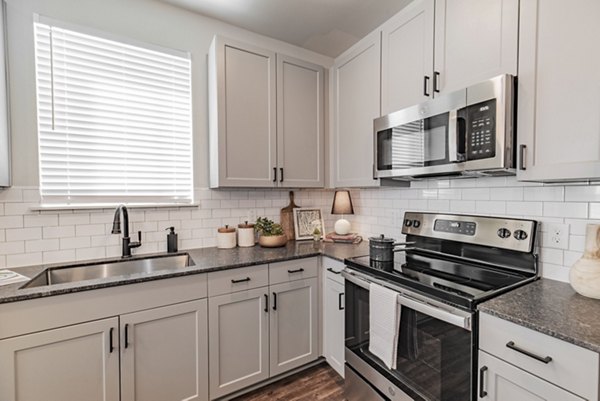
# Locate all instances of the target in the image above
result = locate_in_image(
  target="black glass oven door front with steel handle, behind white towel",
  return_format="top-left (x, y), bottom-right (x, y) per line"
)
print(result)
top-left (344, 269), bottom-right (474, 401)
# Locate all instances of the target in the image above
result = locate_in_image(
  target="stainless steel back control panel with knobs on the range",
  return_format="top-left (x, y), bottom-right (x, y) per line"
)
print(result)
top-left (402, 212), bottom-right (537, 253)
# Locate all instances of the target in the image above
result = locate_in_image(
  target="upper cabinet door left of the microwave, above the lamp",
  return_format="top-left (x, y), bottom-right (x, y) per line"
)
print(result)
top-left (332, 32), bottom-right (381, 187)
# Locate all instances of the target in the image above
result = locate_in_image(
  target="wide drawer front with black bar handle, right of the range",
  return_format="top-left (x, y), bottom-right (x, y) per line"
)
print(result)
top-left (479, 313), bottom-right (599, 400)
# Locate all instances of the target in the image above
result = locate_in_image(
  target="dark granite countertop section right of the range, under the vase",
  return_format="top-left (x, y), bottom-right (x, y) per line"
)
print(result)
top-left (479, 279), bottom-right (600, 352)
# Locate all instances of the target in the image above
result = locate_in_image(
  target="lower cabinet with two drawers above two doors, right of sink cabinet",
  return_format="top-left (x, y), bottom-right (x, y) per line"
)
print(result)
top-left (208, 258), bottom-right (319, 400)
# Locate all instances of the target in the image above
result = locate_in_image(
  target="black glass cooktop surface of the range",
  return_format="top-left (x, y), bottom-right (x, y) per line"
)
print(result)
top-left (345, 250), bottom-right (535, 310)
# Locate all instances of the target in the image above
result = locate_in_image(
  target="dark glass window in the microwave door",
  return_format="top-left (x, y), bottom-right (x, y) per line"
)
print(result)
top-left (377, 113), bottom-right (449, 171)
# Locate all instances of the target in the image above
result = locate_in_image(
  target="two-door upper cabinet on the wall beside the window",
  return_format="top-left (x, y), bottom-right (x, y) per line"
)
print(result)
top-left (208, 36), bottom-right (325, 188)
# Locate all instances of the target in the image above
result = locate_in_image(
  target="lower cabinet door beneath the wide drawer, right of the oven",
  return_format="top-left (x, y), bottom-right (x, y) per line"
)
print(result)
top-left (477, 351), bottom-right (583, 401)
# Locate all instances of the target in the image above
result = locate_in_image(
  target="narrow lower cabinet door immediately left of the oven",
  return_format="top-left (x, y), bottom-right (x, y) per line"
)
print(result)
top-left (323, 278), bottom-right (345, 377)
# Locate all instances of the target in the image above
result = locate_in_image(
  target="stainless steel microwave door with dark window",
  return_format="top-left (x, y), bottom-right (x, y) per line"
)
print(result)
top-left (374, 90), bottom-right (466, 178)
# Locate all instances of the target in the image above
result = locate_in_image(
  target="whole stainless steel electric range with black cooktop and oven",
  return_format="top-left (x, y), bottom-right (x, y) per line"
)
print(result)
top-left (343, 212), bottom-right (538, 401)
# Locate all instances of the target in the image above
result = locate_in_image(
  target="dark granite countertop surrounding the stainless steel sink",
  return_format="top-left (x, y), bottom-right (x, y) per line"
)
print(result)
top-left (0, 241), bottom-right (369, 304)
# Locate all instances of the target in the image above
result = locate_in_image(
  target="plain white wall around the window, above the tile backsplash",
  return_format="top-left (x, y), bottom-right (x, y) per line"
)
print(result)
top-left (7, 0), bottom-right (333, 188)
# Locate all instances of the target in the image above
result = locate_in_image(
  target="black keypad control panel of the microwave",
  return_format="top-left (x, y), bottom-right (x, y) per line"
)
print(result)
top-left (467, 99), bottom-right (496, 160)
